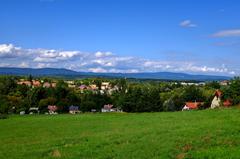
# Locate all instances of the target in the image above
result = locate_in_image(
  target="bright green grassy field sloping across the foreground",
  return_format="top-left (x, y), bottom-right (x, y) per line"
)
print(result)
top-left (0, 108), bottom-right (240, 159)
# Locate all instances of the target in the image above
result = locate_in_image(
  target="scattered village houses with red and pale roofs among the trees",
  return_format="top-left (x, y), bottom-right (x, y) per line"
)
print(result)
top-left (11, 78), bottom-right (233, 115)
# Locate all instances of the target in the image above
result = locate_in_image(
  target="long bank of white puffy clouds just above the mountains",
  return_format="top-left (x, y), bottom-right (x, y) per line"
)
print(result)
top-left (0, 44), bottom-right (236, 75)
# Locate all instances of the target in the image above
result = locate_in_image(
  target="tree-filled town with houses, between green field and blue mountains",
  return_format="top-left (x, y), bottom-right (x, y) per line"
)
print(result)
top-left (0, 75), bottom-right (237, 115)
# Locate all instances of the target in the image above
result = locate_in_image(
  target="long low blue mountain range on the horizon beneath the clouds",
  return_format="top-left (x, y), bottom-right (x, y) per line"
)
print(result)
top-left (0, 67), bottom-right (231, 81)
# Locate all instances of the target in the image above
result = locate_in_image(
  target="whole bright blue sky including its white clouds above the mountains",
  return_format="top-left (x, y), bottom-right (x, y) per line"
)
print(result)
top-left (0, 0), bottom-right (240, 76)
